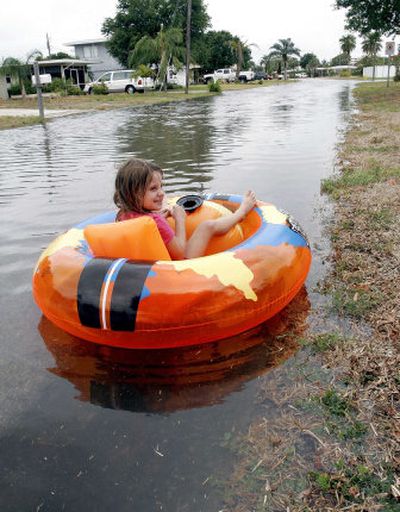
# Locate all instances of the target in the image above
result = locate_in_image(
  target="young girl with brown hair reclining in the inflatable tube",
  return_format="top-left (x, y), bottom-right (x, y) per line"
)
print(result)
top-left (114, 158), bottom-right (256, 260)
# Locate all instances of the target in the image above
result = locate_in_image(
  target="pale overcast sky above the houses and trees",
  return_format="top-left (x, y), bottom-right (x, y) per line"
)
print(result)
top-left (0, 0), bottom-right (394, 62)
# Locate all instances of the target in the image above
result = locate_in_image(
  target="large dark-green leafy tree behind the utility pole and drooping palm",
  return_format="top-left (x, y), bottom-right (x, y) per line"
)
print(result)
top-left (101, 0), bottom-right (210, 66)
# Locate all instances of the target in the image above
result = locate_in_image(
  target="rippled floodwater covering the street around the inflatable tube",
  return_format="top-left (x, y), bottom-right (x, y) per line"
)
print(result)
top-left (0, 79), bottom-right (352, 512)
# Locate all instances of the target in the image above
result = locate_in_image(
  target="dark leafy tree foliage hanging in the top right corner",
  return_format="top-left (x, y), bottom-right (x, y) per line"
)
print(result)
top-left (336, 0), bottom-right (400, 35)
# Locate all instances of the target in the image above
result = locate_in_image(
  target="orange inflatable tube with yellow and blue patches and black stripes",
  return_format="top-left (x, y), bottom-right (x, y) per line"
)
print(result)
top-left (33, 194), bottom-right (311, 349)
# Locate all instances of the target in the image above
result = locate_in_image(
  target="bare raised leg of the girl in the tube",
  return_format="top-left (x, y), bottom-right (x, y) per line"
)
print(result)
top-left (185, 190), bottom-right (256, 258)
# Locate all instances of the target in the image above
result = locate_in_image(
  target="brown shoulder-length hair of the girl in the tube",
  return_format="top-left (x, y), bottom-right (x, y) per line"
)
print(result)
top-left (114, 158), bottom-right (163, 213)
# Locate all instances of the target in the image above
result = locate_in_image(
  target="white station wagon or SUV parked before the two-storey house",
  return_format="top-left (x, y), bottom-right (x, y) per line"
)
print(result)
top-left (84, 69), bottom-right (155, 94)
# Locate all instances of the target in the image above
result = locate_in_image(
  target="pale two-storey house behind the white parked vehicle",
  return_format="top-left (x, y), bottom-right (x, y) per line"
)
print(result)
top-left (64, 37), bottom-right (121, 80)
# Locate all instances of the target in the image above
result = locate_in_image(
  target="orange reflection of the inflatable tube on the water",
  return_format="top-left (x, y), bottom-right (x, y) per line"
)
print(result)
top-left (39, 288), bottom-right (310, 413)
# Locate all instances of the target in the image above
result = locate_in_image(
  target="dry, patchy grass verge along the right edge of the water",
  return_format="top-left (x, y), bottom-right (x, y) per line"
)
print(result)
top-left (220, 83), bottom-right (400, 512)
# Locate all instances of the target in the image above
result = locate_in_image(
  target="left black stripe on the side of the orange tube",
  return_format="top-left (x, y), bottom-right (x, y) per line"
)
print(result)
top-left (78, 258), bottom-right (114, 328)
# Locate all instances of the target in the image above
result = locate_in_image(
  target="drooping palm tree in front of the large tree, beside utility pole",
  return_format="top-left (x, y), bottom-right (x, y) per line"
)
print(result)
top-left (128, 26), bottom-right (185, 90)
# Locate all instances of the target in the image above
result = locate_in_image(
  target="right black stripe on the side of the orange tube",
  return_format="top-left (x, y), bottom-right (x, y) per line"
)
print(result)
top-left (110, 261), bottom-right (153, 331)
